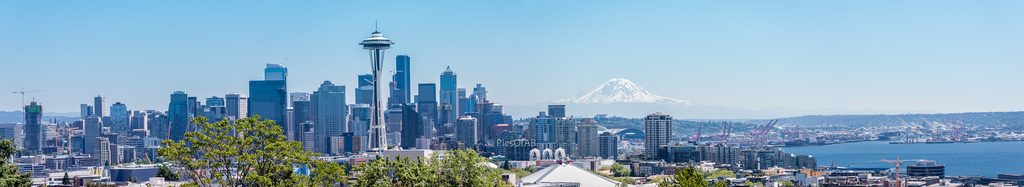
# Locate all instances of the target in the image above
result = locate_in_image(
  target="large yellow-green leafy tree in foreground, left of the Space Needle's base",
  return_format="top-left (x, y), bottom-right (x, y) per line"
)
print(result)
top-left (157, 116), bottom-right (344, 187)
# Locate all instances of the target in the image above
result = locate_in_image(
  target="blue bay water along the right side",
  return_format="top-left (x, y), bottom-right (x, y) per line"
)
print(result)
top-left (783, 141), bottom-right (1024, 177)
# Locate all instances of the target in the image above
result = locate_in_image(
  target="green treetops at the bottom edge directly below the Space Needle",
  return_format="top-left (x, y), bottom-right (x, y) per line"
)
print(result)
top-left (352, 150), bottom-right (509, 187)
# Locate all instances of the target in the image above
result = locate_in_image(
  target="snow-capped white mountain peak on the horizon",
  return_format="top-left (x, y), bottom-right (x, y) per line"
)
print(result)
top-left (555, 78), bottom-right (689, 104)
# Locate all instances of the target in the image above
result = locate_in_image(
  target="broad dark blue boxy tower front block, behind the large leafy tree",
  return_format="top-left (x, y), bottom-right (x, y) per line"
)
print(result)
top-left (247, 81), bottom-right (289, 130)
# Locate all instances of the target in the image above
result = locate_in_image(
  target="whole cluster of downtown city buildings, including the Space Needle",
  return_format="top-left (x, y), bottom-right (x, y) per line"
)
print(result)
top-left (0, 30), bottom-right (839, 184)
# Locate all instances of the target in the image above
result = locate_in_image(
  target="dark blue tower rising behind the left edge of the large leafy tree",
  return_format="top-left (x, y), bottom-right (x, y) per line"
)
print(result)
top-left (167, 91), bottom-right (191, 141)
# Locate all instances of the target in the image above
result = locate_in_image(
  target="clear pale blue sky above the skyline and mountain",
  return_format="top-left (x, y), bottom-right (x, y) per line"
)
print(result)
top-left (0, 0), bottom-right (1024, 117)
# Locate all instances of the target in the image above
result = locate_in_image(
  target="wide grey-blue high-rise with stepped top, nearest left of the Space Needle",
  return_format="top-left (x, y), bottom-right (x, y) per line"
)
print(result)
top-left (312, 81), bottom-right (348, 154)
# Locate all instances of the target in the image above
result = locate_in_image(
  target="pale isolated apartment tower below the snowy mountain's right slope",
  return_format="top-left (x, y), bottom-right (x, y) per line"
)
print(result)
top-left (643, 112), bottom-right (672, 159)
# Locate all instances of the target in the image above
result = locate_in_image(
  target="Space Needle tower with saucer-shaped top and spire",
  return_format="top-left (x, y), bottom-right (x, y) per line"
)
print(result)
top-left (359, 31), bottom-right (394, 150)
